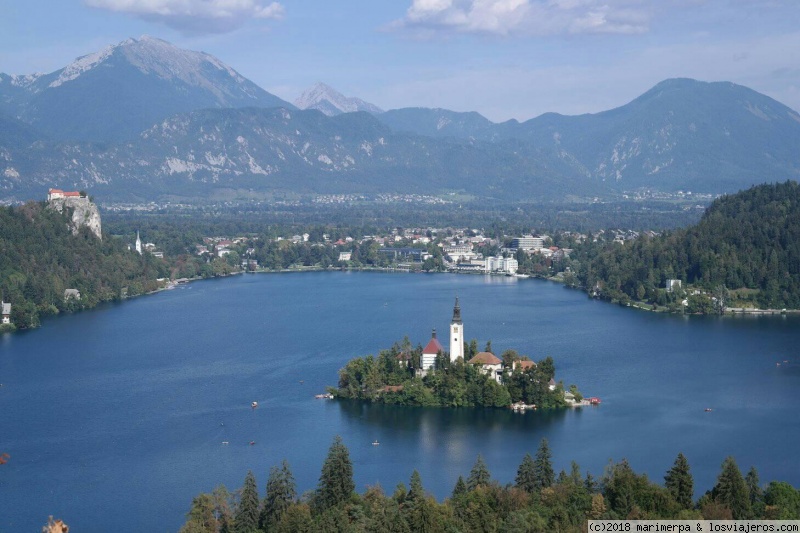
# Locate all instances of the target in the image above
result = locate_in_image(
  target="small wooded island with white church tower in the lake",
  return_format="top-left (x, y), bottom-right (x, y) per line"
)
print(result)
top-left (328, 298), bottom-right (588, 411)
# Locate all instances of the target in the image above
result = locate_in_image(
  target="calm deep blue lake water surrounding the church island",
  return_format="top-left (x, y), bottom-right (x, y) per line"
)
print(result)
top-left (0, 272), bottom-right (800, 532)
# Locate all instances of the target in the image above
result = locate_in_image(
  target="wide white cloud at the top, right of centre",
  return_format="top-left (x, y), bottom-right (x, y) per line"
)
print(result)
top-left (392, 0), bottom-right (652, 36)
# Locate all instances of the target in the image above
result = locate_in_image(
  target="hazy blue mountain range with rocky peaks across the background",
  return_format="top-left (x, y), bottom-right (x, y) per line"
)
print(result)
top-left (0, 37), bottom-right (800, 201)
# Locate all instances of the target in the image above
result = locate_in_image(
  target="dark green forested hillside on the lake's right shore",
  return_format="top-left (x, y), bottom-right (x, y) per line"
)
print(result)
top-left (575, 181), bottom-right (800, 312)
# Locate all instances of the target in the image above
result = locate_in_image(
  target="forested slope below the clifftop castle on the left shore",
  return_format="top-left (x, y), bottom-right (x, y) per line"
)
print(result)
top-left (0, 202), bottom-right (169, 329)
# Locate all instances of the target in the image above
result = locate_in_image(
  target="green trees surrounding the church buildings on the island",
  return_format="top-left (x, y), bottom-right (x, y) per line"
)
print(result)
top-left (331, 338), bottom-right (581, 409)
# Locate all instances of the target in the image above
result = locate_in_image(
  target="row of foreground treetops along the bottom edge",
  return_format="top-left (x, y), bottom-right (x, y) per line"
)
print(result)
top-left (180, 437), bottom-right (800, 533)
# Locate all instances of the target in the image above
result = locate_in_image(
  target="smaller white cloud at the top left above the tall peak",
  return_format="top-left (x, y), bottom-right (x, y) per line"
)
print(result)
top-left (84, 0), bottom-right (284, 34)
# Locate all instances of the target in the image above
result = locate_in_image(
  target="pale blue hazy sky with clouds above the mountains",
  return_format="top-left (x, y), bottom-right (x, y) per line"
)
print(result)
top-left (0, 0), bottom-right (800, 121)
